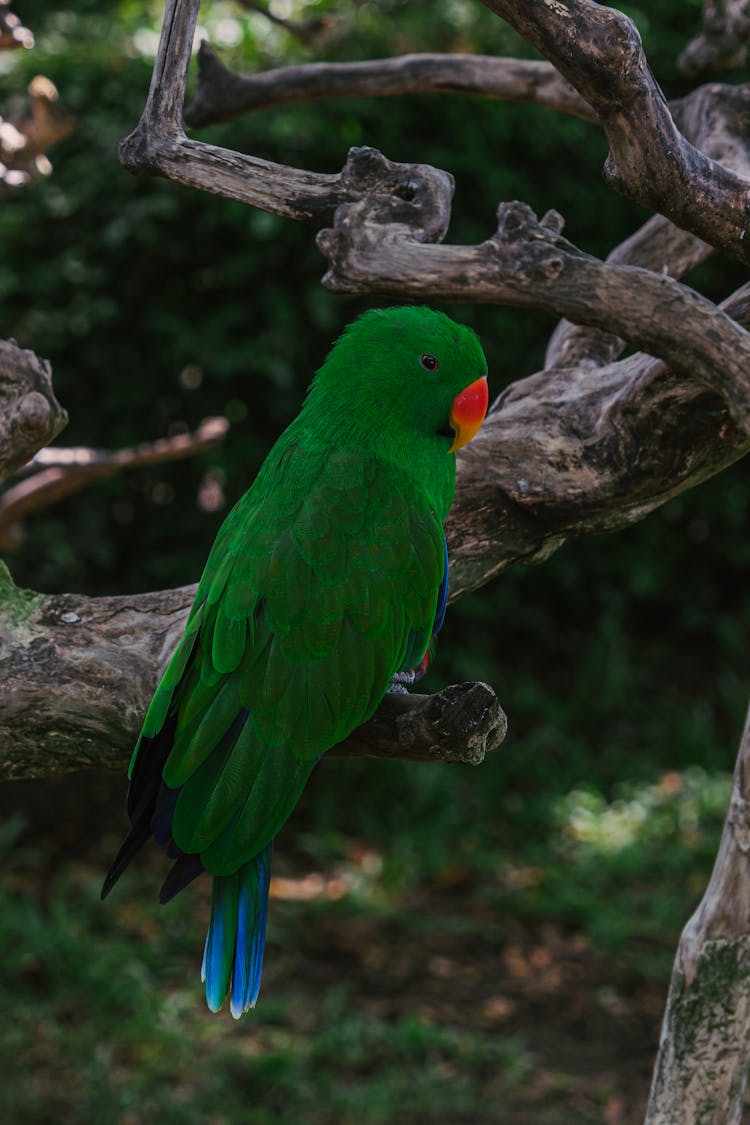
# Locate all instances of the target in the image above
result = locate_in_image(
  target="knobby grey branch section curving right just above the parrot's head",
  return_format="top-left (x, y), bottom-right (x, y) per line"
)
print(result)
top-left (317, 199), bottom-right (750, 429)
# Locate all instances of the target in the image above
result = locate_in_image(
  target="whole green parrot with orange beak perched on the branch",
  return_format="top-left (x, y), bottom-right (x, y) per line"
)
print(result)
top-left (101, 307), bottom-right (487, 1018)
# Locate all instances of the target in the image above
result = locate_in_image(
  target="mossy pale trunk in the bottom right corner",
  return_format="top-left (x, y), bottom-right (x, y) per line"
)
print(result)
top-left (645, 712), bottom-right (750, 1125)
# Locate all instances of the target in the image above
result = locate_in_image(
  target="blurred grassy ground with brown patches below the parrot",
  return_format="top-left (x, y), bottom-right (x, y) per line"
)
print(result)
top-left (0, 763), bottom-right (728, 1125)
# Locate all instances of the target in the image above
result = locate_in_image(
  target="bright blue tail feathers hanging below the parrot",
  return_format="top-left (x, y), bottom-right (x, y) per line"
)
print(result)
top-left (200, 844), bottom-right (271, 1019)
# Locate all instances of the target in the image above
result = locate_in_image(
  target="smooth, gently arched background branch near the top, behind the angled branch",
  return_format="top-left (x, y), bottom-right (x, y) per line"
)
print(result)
top-left (184, 41), bottom-right (597, 128)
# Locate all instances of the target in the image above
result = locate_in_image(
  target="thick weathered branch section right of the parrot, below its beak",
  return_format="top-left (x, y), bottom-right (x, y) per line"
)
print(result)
top-left (446, 356), bottom-right (750, 597)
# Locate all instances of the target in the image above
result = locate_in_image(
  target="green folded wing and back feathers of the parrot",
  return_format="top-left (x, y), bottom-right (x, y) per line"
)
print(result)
top-left (136, 447), bottom-right (443, 874)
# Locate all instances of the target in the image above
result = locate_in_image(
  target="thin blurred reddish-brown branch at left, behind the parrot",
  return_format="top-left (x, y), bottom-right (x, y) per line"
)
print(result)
top-left (0, 417), bottom-right (229, 550)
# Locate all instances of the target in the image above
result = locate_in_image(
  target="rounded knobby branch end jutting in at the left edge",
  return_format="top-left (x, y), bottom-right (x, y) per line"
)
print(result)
top-left (0, 340), bottom-right (67, 480)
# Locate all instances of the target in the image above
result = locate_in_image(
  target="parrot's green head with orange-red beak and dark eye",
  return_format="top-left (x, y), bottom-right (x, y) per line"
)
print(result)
top-left (311, 306), bottom-right (488, 452)
